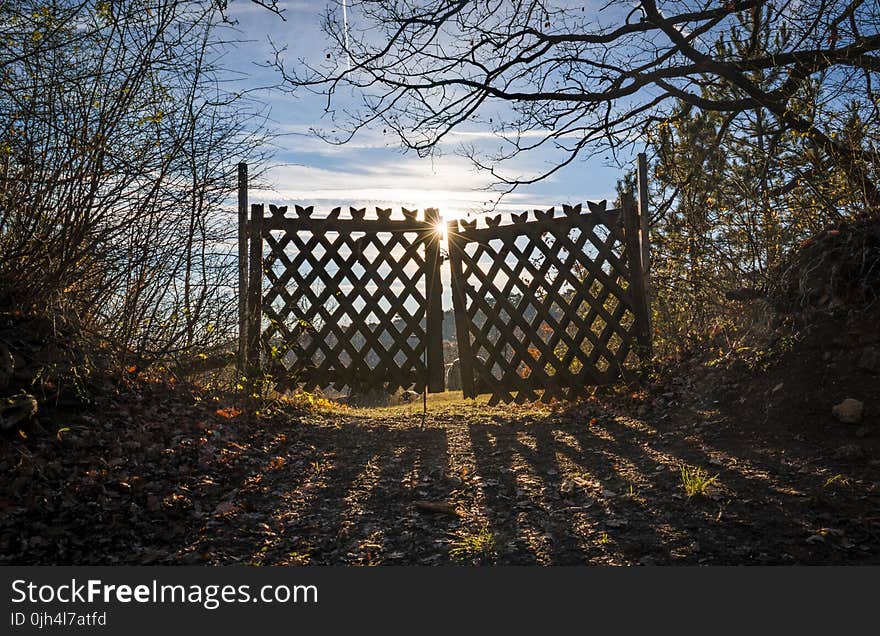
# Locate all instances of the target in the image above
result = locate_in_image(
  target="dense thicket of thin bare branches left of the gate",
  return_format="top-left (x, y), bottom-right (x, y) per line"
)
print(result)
top-left (0, 0), bottom-right (276, 368)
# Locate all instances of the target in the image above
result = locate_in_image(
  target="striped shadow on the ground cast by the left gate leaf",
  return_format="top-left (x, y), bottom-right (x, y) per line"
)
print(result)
top-left (192, 420), bottom-right (457, 565)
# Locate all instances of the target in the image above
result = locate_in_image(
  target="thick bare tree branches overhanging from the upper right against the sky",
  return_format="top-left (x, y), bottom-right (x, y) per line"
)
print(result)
top-left (276, 0), bottom-right (880, 206)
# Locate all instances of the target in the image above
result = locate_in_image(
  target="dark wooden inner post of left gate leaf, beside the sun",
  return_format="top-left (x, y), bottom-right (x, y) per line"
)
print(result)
top-left (425, 208), bottom-right (446, 393)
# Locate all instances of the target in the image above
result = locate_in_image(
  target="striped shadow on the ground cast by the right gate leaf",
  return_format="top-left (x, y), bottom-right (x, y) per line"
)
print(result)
top-left (467, 402), bottom-right (860, 565)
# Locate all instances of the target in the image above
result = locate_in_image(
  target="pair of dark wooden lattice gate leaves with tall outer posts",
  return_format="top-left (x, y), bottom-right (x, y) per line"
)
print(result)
top-left (239, 157), bottom-right (651, 403)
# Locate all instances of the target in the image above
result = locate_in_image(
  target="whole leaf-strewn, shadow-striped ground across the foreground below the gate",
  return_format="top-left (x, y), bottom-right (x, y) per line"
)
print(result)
top-left (0, 382), bottom-right (880, 565)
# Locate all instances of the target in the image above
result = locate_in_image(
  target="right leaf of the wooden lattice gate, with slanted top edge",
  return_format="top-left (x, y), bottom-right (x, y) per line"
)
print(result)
top-left (450, 202), bottom-right (644, 403)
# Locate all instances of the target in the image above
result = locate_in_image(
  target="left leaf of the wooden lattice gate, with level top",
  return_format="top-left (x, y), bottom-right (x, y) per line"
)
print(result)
top-left (262, 206), bottom-right (442, 391)
